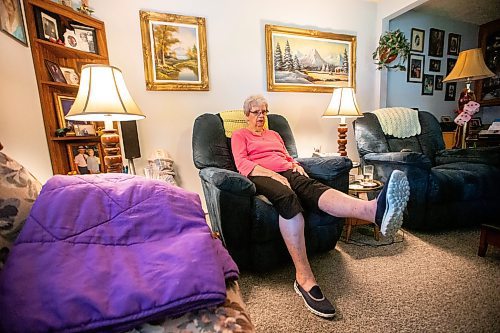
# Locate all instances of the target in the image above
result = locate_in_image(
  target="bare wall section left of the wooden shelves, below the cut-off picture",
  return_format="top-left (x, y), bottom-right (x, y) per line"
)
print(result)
top-left (0, 9), bottom-right (52, 182)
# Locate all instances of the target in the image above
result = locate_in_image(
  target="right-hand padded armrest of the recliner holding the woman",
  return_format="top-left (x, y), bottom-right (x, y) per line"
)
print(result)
top-left (296, 156), bottom-right (352, 180)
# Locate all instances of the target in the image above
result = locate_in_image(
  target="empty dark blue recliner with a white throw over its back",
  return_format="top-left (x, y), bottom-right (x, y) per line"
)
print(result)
top-left (354, 111), bottom-right (500, 229)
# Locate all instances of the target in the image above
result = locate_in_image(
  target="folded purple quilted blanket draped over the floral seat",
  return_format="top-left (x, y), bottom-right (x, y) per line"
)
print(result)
top-left (0, 174), bottom-right (238, 332)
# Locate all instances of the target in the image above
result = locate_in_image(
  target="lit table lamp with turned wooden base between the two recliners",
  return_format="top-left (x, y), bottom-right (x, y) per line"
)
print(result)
top-left (323, 88), bottom-right (363, 156)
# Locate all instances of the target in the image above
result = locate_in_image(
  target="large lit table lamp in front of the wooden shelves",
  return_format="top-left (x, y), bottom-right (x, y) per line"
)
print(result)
top-left (65, 64), bottom-right (145, 172)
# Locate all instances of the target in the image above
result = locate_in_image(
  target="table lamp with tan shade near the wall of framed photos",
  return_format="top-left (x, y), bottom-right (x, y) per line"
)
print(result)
top-left (443, 48), bottom-right (495, 148)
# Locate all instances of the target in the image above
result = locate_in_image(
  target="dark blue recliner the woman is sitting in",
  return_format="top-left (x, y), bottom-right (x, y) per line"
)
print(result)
top-left (193, 114), bottom-right (352, 271)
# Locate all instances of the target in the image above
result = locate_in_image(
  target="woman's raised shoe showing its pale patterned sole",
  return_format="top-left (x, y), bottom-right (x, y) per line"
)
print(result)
top-left (375, 170), bottom-right (410, 236)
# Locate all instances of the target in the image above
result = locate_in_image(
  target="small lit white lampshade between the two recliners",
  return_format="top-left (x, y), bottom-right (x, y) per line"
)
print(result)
top-left (323, 88), bottom-right (363, 119)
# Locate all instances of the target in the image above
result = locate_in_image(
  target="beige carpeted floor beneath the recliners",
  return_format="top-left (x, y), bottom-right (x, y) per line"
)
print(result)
top-left (240, 228), bottom-right (500, 333)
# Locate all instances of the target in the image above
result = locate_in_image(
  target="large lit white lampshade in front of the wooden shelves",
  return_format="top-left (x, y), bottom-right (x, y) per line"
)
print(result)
top-left (65, 64), bottom-right (145, 121)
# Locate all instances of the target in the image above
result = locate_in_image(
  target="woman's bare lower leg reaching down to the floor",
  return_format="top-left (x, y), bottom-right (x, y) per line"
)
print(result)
top-left (279, 213), bottom-right (316, 290)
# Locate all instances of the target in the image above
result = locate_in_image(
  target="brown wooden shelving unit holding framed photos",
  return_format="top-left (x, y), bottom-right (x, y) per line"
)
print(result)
top-left (24, 0), bottom-right (109, 174)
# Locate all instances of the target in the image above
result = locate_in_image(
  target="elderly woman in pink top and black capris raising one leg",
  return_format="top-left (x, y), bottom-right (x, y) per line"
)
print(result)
top-left (231, 96), bottom-right (409, 318)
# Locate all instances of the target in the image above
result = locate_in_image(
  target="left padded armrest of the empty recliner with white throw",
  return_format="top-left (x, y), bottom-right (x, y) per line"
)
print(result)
top-left (363, 152), bottom-right (432, 170)
